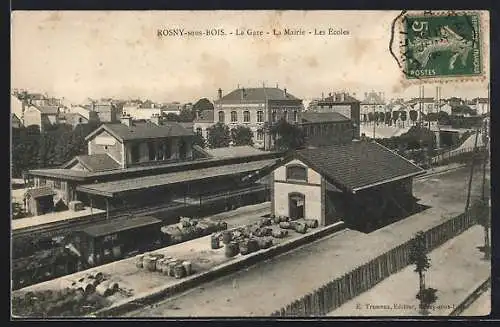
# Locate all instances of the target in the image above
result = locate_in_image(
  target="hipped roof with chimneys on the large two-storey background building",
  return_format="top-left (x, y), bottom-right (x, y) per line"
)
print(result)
top-left (215, 87), bottom-right (300, 103)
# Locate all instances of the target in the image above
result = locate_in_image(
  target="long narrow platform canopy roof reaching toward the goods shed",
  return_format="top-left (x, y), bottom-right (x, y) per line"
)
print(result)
top-left (77, 159), bottom-right (277, 197)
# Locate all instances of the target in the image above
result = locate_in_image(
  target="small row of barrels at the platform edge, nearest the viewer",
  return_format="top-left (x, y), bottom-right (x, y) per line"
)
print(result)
top-left (136, 253), bottom-right (193, 279)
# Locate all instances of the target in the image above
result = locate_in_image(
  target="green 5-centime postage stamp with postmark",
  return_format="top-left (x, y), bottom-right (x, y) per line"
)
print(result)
top-left (398, 11), bottom-right (485, 82)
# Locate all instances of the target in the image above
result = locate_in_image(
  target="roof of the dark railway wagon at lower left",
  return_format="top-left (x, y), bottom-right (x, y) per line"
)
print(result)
top-left (82, 216), bottom-right (162, 237)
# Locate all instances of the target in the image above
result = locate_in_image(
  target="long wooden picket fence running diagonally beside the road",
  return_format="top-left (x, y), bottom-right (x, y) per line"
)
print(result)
top-left (271, 207), bottom-right (478, 317)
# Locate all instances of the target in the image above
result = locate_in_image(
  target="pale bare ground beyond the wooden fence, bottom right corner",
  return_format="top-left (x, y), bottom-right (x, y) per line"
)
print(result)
top-left (328, 226), bottom-right (491, 316)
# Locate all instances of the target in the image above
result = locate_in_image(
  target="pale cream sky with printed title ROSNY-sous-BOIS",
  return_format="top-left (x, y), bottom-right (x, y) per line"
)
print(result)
top-left (11, 11), bottom-right (489, 103)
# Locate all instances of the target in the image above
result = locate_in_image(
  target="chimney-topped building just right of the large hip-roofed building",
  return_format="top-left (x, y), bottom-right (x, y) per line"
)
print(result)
top-left (308, 92), bottom-right (360, 139)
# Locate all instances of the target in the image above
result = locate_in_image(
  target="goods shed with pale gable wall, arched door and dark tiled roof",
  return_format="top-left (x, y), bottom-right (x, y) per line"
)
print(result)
top-left (271, 140), bottom-right (424, 230)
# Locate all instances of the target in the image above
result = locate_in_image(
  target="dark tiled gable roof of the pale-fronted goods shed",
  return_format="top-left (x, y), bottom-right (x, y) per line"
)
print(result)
top-left (297, 141), bottom-right (424, 193)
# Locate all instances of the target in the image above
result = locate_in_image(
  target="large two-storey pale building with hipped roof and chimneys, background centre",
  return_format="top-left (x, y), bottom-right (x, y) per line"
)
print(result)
top-left (213, 87), bottom-right (304, 150)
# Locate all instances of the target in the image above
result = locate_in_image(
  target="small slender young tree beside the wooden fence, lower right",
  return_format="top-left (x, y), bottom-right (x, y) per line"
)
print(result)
top-left (409, 232), bottom-right (437, 313)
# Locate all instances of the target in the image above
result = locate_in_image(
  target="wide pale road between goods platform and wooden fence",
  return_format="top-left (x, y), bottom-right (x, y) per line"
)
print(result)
top-left (125, 167), bottom-right (488, 317)
